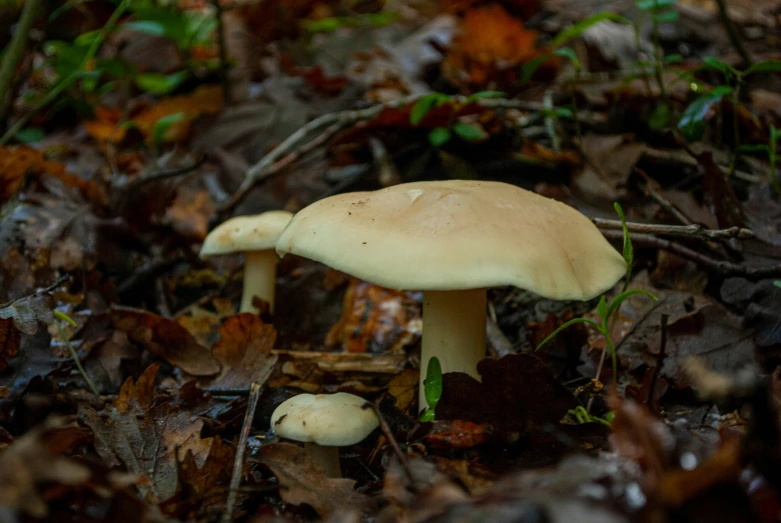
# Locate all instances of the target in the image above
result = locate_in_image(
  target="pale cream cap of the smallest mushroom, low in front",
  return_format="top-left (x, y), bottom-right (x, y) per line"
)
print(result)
top-left (271, 392), bottom-right (380, 447)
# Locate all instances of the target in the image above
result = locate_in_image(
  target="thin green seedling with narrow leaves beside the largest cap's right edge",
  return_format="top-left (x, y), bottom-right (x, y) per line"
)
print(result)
top-left (536, 203), bottom-right (658, 384)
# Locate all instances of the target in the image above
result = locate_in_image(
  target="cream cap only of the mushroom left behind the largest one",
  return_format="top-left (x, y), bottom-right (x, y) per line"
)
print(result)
top-left (201, 211), bottom-right (293, 258)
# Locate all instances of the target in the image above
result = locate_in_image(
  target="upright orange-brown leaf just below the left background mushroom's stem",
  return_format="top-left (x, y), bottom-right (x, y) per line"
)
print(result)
top-left (209, 312), bottom-right (277, 389)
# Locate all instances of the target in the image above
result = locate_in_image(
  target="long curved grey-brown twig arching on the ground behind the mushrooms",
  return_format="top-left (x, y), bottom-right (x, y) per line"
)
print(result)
top-left (218, 95), bottom-right (543, 213)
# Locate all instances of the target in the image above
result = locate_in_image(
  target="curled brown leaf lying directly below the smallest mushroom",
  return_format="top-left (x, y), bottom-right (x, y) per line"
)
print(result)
top-left (256, 443), bottom-right (375, 518)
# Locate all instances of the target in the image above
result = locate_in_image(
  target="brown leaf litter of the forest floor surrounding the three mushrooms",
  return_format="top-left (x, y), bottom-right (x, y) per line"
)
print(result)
top-left (0, 0), bottom-right (781, 522)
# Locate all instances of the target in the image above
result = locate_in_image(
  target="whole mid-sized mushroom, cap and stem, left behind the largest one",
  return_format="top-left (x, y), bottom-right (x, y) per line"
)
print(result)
top-left (200, 211), bottom-right (293, 314)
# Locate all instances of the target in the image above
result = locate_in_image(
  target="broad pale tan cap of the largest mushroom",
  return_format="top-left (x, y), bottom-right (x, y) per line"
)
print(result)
top-left (277, 180), bottom-right (626, 300)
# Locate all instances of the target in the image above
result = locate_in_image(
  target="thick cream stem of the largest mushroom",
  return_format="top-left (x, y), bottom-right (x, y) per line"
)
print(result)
top-left (418, 288), bottom-right (486, 409)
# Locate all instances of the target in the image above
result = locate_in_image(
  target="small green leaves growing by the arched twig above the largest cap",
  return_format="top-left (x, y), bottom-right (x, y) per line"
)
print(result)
top-left (409, 91), bottom-right (504, 147)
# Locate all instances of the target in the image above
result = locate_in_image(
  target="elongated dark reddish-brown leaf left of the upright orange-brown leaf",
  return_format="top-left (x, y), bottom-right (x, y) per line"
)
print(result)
top-left (110, 307), bottom-right (220, 376)
